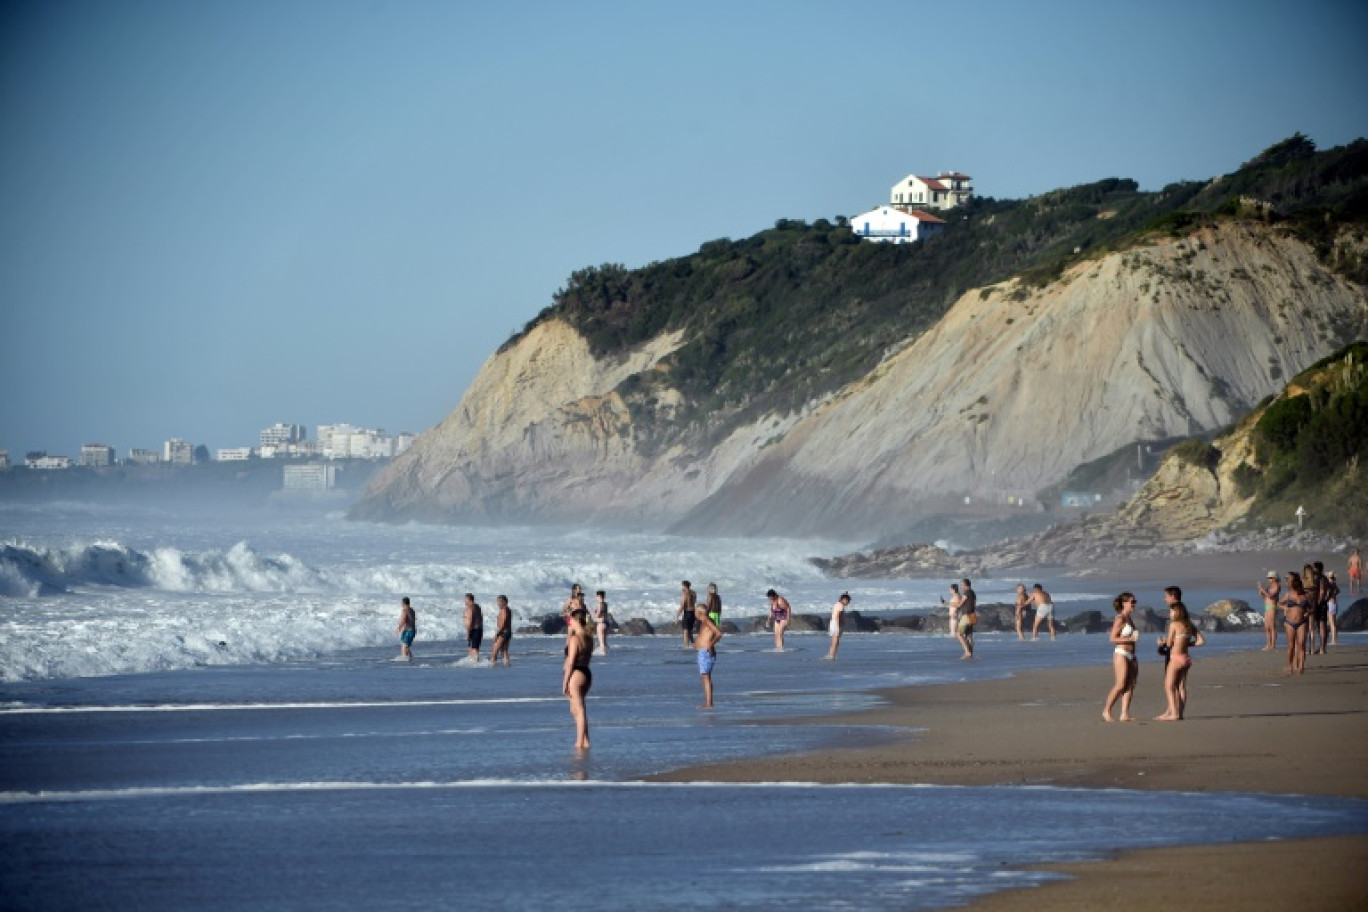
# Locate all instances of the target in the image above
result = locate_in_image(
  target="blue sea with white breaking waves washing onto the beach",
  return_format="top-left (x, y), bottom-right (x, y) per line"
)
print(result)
top-left (0, 503), bottom-right (1368, 909)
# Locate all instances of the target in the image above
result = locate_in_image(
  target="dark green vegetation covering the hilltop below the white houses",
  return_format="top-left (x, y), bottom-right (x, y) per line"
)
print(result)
top-left (506, 134), bottom-right (1368, 450)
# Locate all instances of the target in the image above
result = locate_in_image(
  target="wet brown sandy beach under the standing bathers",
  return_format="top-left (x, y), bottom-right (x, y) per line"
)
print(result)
top-left (662, 642), bottom-right (1368, 912)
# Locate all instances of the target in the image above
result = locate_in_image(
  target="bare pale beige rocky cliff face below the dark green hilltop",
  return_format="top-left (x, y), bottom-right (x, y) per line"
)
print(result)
top-left (356, 223), bottom-right (1368, 539)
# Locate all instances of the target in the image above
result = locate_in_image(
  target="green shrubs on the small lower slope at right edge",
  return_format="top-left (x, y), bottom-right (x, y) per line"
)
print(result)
top-left (1235, 342), bottom-right (1368, 535)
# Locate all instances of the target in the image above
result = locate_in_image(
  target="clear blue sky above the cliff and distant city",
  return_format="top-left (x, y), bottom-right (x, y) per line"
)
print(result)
top-left (0, 0), bottom-right (1368, 458)
